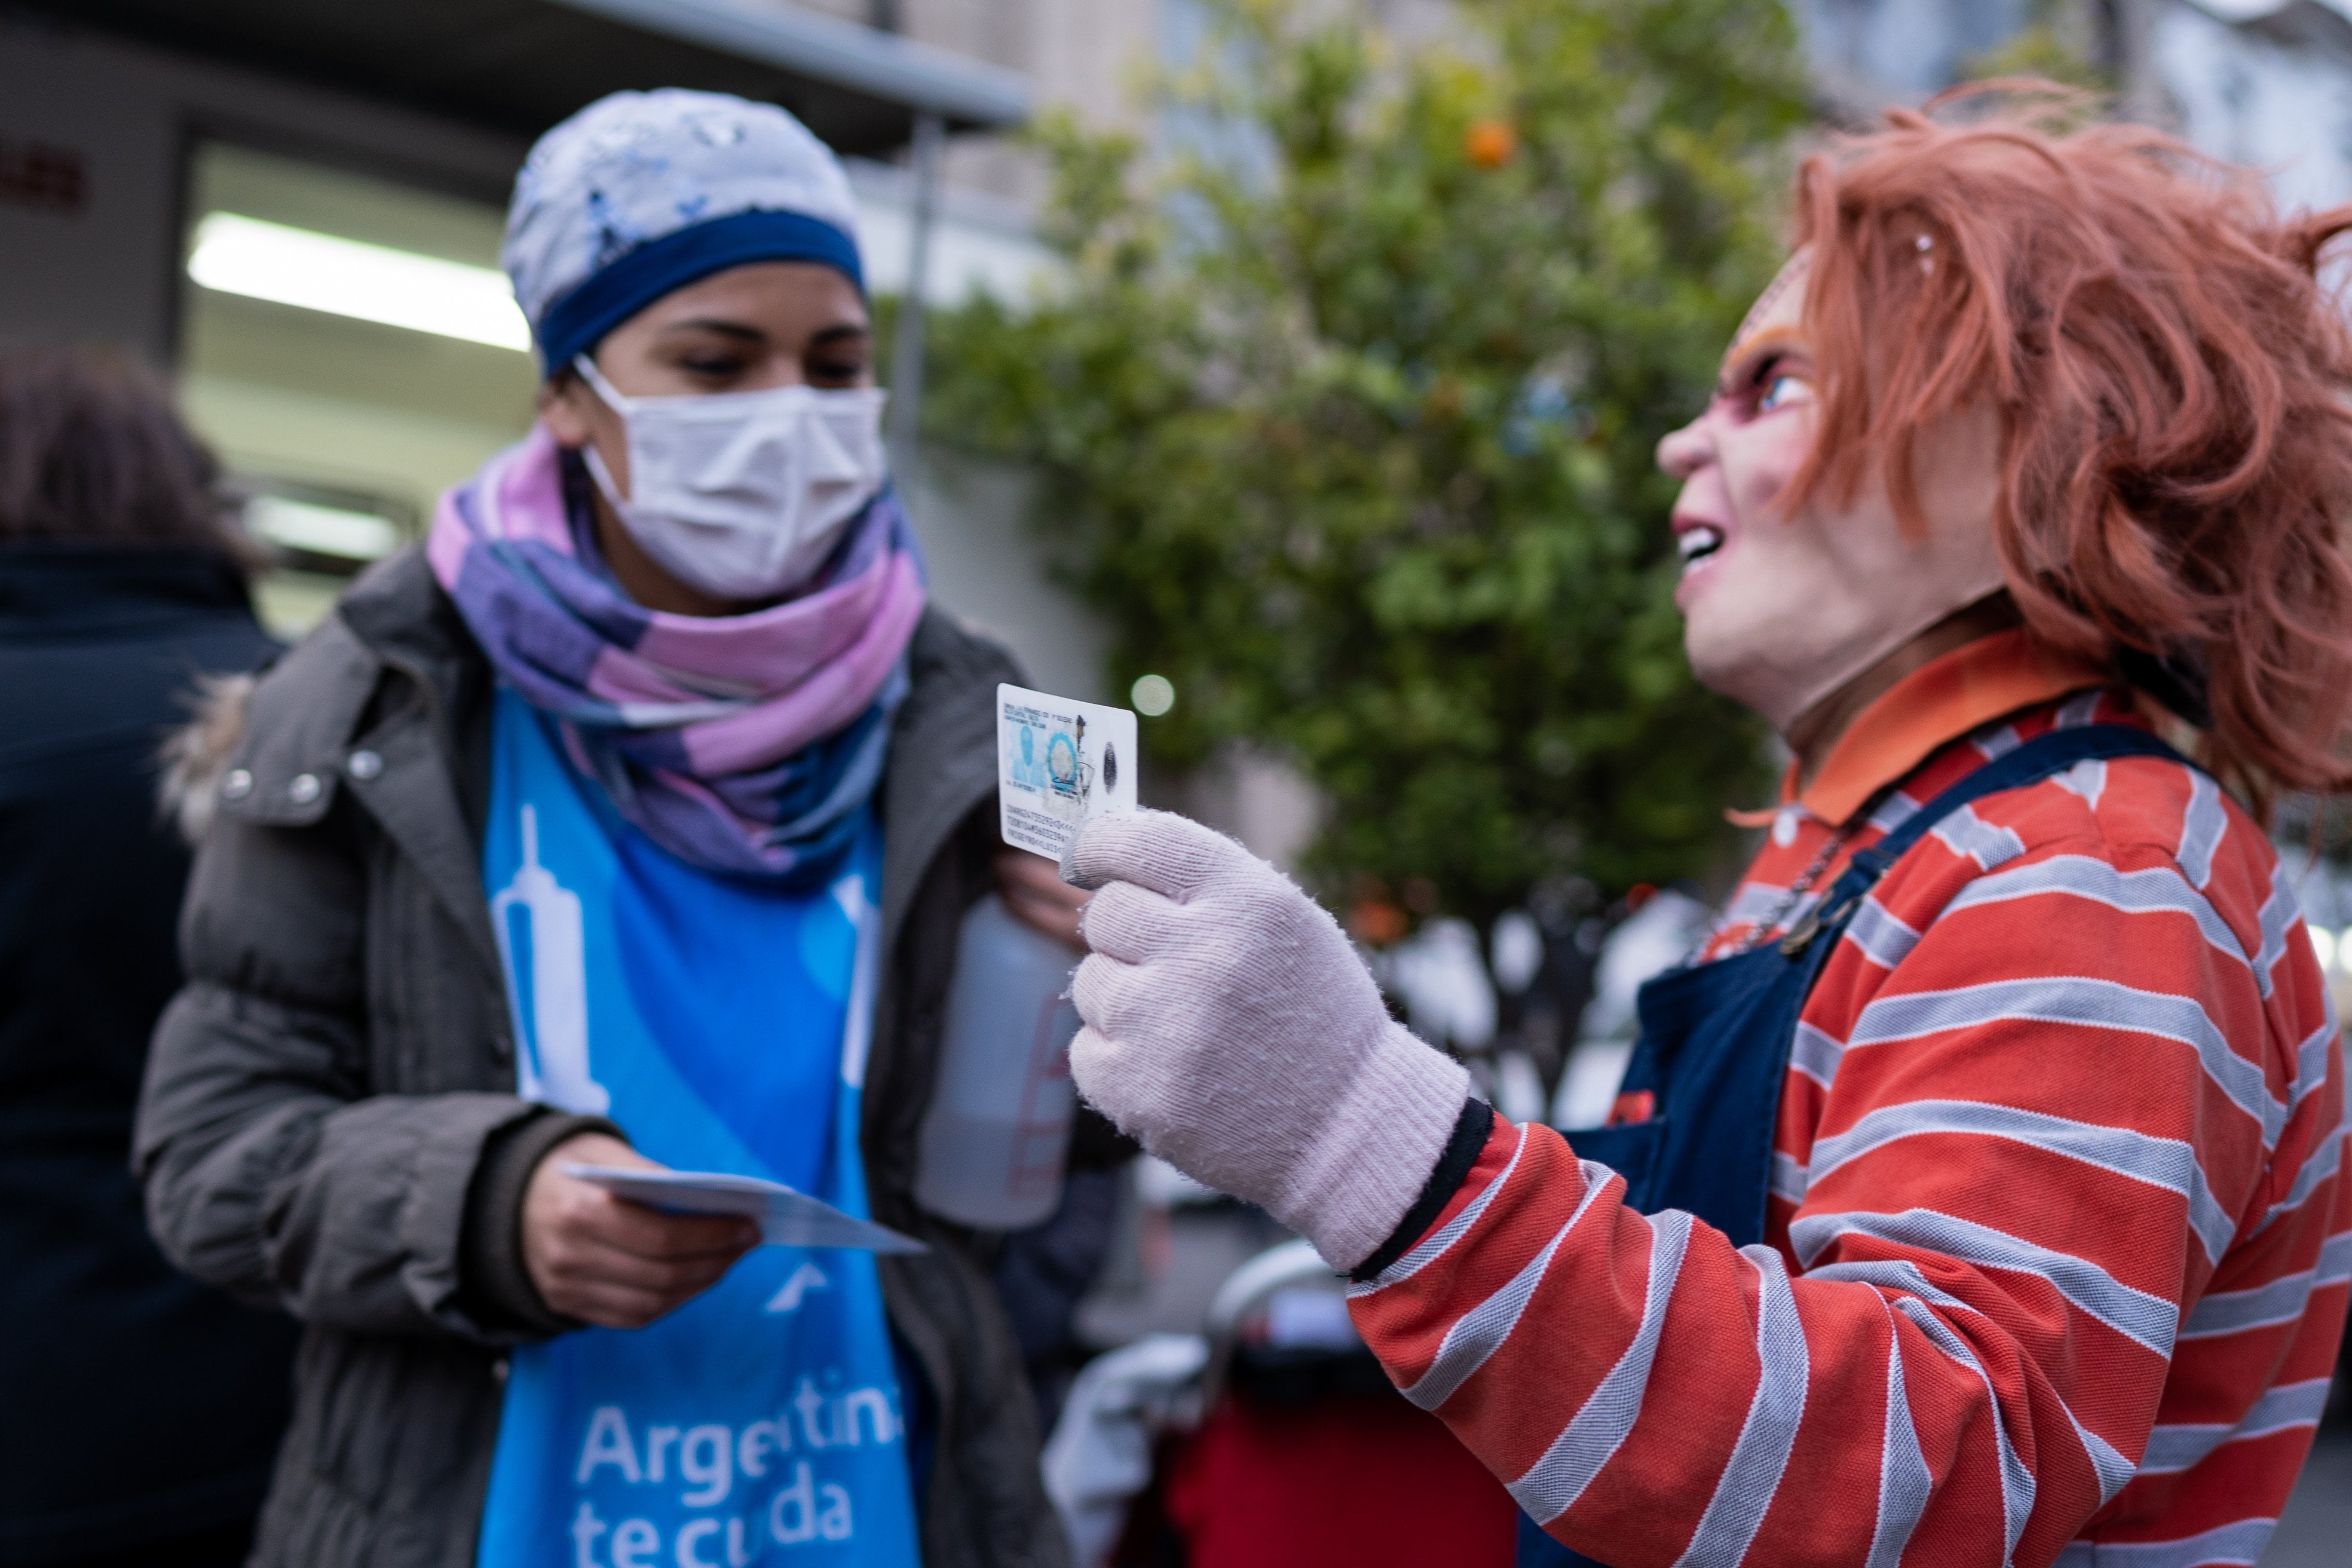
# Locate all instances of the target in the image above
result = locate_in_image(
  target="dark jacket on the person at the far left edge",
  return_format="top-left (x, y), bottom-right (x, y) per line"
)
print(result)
top-left (0, 543), bottom-right (294, 1563)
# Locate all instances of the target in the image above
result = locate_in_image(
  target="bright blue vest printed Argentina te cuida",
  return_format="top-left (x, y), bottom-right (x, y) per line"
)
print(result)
top-left (477, 687), bottom-right (920, 1568)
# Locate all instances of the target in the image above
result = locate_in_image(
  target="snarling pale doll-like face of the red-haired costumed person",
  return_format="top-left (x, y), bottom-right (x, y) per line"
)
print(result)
top-left (1658, 254), bottom-right (2002, 733)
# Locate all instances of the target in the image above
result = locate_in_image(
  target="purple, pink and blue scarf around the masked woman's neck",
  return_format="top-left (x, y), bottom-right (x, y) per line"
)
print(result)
top-left (425, 428), bottom-right (924, 889)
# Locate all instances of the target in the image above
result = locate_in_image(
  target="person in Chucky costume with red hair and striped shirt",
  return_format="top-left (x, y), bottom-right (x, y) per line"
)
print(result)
top-left (1073, 98), bottom-right (2352, 1568)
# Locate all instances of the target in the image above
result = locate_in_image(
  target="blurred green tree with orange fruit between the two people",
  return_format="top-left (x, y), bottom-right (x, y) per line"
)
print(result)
top-left (927, 0), bottom-right (1806, 919)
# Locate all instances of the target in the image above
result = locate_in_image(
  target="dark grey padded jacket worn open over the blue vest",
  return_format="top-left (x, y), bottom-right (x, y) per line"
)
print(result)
top-left (136, 548), bottom-right (1068, 1568)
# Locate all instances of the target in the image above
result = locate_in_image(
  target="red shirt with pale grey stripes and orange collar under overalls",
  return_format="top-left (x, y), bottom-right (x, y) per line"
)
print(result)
top-left (1352, 632), bottom-right (2352, 1568)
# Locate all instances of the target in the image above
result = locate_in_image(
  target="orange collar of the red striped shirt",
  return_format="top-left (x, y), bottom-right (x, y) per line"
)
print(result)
top-left (1750, 627), bottom-right (2110, 828)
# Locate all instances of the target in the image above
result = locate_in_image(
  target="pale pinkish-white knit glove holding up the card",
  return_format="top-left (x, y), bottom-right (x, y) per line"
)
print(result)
top-left (1065, 811), bottom-right (1470, 1269)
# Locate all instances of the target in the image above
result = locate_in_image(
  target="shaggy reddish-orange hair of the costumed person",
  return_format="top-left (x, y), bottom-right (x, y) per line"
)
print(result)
top-left (1785, 82), bottom-right (2352, 813)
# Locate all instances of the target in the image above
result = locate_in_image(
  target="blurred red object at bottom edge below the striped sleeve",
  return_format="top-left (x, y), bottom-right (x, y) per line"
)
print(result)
top-left (1164, 1394), bottom-right (1520, 1568)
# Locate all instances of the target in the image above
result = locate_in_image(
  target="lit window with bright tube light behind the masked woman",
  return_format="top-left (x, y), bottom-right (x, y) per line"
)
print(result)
top-left (179, 143), bottom-right (538, 635)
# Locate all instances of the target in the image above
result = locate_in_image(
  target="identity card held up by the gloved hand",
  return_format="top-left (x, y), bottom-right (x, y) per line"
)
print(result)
top-left (997, 687), bottom-right (1136, 860)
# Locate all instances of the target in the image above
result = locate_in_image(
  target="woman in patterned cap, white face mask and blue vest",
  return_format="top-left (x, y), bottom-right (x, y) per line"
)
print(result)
top-left (139, 91), bottom-right (1073, 1568)
